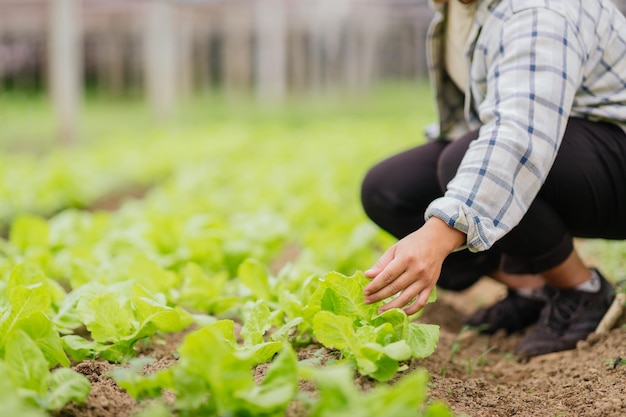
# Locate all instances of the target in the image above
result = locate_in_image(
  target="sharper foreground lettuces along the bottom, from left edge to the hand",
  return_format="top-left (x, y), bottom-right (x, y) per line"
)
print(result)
top-left (0, 261), bottom-right (451, 417)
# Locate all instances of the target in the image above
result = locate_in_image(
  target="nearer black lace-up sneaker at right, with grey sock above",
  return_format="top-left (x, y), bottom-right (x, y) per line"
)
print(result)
top-left (515, 271), bottom-right (615, 359)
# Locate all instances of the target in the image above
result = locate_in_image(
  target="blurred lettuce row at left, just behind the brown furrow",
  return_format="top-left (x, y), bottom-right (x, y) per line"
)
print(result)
top-left (0, 126), bottom-right (258, 232)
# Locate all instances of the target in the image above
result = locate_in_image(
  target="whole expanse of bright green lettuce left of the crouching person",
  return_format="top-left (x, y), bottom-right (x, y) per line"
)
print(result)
top-left (0, 95), bottom-right (450, 417)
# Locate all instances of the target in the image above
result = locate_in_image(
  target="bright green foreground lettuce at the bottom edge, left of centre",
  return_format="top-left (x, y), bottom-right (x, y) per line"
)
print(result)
top-left (112, 320), bottom-right (298, 417)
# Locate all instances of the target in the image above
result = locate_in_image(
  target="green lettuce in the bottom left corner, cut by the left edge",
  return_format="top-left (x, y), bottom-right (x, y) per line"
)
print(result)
top-left (0, 263), bottom-right (91, 415)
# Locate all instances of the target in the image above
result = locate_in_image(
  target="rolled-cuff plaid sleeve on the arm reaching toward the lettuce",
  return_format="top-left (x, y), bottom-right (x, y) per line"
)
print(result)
top-left (425, 8), bottom-right (585, 252)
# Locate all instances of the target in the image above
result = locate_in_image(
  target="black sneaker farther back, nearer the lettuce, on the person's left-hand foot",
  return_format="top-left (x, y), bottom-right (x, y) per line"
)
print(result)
top-left (465, 289), bottom-right (545, 334)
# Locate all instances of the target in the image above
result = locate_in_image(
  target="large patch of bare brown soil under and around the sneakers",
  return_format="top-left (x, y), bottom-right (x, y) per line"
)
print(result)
top-left (413, 280), bottom-right (626, 417)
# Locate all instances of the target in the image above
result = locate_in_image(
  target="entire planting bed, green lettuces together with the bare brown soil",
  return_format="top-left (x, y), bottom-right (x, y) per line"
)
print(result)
top-left (0, 87), bottom-right (626, 417)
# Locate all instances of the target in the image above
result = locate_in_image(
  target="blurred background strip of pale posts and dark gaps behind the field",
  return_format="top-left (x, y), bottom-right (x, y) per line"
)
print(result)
top-left (0, 0), bottom-right (626, 141)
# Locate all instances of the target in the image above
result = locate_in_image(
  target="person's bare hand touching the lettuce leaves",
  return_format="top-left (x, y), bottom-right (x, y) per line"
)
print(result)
top-left (363, 217), bottom-right (466, 315)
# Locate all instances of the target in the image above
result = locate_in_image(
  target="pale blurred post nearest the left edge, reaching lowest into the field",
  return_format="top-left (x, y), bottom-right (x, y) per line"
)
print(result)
top-left (49, 0), bottom-right (82, 145)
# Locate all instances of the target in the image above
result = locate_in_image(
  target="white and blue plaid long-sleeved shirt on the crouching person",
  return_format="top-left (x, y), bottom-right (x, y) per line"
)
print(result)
top-left (425, 0), bottom-right (626, 251)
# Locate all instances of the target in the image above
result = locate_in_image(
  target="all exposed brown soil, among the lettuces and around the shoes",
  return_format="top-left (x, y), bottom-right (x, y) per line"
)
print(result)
top-left (55, 279), bottom-right (626, 417)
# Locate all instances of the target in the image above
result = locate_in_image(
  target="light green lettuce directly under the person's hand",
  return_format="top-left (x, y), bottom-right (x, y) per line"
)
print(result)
top-left (304, 272), bottom-right (439, 381)
